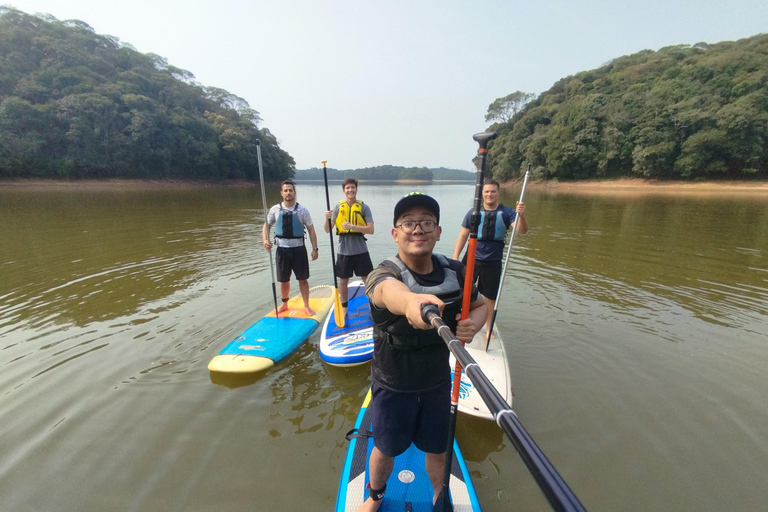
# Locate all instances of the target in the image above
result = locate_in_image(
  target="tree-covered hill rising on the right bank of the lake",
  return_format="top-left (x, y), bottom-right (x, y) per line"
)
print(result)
top-left (486, 35), bottom-right (768, 180)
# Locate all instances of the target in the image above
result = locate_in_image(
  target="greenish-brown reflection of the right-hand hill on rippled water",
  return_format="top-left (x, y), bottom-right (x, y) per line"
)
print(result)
top-left (516, 193), bottom-right (768, 327)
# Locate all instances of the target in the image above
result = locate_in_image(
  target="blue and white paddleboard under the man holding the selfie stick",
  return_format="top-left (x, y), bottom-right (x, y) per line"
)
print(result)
top-left (336, 390), bottom-right (480, 512)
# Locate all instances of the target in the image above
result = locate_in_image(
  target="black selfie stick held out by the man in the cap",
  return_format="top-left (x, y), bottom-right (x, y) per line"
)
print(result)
top-left (421, 304), bottom-right (586, 512)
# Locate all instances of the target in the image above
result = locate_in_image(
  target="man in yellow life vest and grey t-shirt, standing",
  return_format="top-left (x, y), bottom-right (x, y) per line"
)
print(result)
top-left (324, 178), bottom-right (373, 316)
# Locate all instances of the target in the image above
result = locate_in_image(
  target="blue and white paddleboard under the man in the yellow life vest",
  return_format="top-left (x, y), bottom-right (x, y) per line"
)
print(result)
top-left (320, 281), bottom-right (373, 366)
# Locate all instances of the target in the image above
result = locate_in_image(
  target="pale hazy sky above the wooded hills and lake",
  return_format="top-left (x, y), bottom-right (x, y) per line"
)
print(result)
top-left (6, 0), bottom-right (768, 170)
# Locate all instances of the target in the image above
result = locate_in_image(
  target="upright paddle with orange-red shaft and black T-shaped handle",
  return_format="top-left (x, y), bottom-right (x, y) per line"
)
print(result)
top-left (433, 132), bottom-right (499, 512)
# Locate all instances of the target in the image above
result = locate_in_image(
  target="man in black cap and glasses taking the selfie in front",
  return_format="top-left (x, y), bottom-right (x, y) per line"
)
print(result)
top-left (358, 192), bottom-right (486, 511)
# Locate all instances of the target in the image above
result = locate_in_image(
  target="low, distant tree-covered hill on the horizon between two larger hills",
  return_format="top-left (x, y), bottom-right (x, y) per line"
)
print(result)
top-left (296, 165), bottom-right (476, 181)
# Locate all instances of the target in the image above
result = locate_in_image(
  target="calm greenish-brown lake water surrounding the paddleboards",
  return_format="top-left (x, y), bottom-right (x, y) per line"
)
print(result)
top-left (0, 184), bottom-right (768, 512)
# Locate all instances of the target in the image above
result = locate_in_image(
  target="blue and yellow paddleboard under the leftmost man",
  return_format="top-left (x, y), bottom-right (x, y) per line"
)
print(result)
top-left (208, 286), bottom-right (333, 373)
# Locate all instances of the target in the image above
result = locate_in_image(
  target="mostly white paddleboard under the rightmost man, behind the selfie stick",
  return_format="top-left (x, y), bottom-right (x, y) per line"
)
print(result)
top-left (451, 327), bottom-right (513, 420)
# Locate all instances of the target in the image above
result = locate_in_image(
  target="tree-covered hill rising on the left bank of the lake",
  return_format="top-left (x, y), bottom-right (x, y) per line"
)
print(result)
top-left (0, 7), bottom-right (295, 179)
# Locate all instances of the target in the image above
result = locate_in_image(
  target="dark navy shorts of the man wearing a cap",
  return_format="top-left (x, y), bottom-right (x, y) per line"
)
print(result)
top-left (369, 382), bottom-right (451, 457)
